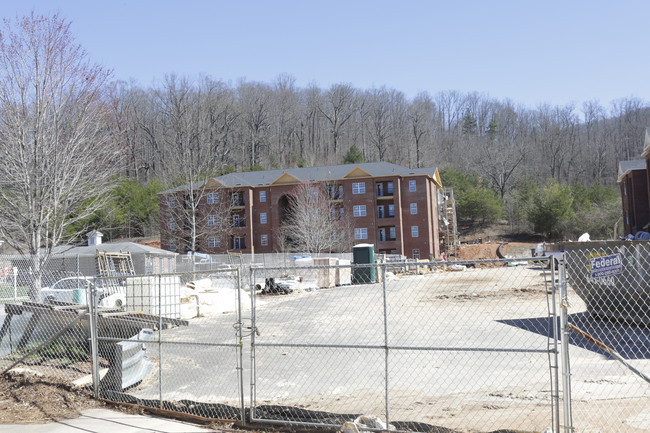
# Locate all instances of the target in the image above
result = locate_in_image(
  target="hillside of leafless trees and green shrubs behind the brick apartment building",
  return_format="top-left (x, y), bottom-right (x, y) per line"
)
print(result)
top-left (100, 75), bottom-right (650, 237)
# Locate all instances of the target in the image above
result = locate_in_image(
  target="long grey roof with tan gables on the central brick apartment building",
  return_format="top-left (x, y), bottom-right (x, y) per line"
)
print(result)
top-left (161, 162), bottom-right (442, 194)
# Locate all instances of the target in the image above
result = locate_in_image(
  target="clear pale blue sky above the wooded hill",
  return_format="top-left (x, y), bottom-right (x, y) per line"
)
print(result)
top-left (0, 0), bottom-right (650, 108)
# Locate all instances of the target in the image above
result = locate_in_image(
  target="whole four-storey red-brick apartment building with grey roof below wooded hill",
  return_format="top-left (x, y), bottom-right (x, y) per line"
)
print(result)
top-left (159, 162), bottom-right (443, 259)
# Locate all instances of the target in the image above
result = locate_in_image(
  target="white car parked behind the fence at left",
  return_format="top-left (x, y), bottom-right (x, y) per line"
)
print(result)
top-left (41, 277), bottom-right (125, 308)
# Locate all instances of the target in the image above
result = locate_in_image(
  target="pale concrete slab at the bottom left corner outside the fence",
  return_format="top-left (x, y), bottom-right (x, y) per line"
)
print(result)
top-left (0, 409), bottom-right (215, 433)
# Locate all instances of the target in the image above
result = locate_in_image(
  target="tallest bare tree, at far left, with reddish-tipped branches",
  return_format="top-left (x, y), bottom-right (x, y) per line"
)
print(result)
top-left (0, 13), bottom-right (118, 300)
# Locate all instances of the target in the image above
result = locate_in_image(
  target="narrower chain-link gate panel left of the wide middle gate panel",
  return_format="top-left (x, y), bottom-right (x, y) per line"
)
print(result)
top-left (91, 269), bottom-right (250, 420)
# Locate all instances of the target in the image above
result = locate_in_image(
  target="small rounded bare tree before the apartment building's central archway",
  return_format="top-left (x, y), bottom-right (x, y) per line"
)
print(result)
top-left (284, 183), bottom-right (352, 254)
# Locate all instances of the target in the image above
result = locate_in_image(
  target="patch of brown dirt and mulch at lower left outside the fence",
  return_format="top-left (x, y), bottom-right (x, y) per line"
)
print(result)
top-left (0, 371), bottom-right (106, 424)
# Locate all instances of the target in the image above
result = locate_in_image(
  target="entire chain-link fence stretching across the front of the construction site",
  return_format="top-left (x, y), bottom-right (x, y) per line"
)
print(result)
top-left (0, 251), bottom-right (650, 433)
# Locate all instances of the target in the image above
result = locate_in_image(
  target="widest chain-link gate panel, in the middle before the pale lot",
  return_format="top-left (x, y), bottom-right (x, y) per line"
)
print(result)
top-left (250, 260), bottom-right (560, 432)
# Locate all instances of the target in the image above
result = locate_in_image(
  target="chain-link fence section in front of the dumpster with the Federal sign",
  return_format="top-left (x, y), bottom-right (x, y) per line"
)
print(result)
top-left (562, 241), bottom-right (650, 432)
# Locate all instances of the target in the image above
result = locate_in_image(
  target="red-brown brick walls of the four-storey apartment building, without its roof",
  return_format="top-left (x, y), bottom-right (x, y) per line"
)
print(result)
top-left (160, 163), bottom-right (440, 258)
